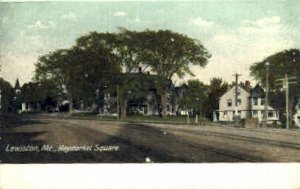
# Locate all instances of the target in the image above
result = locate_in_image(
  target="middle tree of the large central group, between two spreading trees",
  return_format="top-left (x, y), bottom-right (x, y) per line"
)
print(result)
top-left (76, 30), bottom-right (141, 119)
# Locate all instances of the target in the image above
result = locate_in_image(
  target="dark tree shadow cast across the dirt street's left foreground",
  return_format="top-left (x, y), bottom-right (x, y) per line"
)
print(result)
top-left (0, 120), bottom-right (260, 163)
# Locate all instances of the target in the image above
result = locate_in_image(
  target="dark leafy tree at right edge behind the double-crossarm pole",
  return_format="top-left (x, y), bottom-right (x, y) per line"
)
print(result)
top-left (250, 49), bottom-right (300, 125)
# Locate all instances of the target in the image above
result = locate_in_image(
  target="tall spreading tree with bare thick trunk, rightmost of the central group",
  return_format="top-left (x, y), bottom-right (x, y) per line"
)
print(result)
top-left (123, 30), bottom-right (210, 118)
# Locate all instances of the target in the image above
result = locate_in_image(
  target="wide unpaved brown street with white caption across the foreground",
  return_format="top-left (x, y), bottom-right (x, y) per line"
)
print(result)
top-left (0, 116), bottom-right (300, 163)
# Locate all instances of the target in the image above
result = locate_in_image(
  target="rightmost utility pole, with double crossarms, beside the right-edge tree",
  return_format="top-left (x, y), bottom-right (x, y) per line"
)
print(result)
top-left (276, 74), bottom-right (296, 129)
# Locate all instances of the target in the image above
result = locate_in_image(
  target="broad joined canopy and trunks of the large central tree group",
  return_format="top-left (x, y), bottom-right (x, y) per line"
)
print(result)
top-left (35, 29), bottom-right (210, 117)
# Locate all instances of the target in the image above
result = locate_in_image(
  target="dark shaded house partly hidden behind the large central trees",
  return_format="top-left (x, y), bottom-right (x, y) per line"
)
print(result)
top-left (99, 69), bottom-right (178, 116)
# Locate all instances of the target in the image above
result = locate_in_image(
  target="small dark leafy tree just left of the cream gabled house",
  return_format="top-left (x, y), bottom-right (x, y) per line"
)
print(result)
top-left (179, 80), bottom-right (208, 116)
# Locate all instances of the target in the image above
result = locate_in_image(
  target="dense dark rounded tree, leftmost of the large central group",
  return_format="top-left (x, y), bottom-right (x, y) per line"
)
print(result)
top-left (36, 37), bottom-right (120, 112)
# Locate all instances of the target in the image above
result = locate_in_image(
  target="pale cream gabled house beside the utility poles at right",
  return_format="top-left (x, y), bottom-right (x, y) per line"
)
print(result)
top-left (213, 84), bottom-right (279, 123)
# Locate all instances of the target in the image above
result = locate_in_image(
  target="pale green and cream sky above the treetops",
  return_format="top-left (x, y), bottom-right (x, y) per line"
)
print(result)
top-left (0, 0), bottom-right (300, 85)
